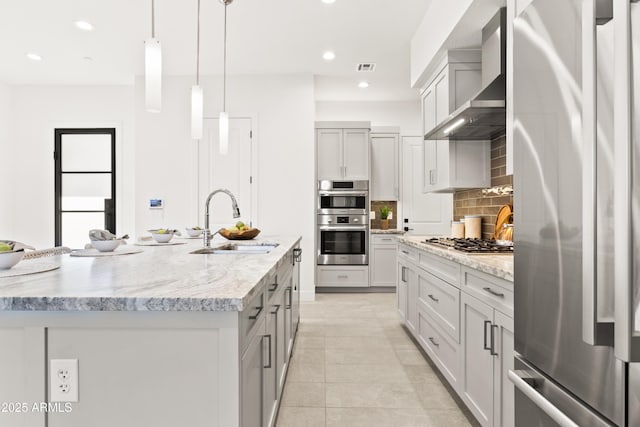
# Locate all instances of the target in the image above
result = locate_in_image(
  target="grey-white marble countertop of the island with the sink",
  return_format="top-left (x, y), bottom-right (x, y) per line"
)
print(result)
top-left (0, 236), bottom-right (300, 311)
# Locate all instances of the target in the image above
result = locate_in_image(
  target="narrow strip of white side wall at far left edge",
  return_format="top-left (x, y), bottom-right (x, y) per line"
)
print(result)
top-left (0, 83), bottom-right (17, 239)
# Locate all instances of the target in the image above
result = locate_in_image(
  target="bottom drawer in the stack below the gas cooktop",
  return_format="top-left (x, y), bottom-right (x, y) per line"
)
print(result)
top-left (417, 309), bottom-right (460, 391)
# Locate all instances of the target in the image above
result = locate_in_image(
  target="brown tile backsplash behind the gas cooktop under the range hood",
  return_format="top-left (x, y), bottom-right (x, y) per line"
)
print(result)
top-left (453, 136), bottom-right (513, 239)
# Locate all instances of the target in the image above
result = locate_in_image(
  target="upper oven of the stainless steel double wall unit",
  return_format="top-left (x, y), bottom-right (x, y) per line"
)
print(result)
top-left (318, 181), bottom-right (369, 216)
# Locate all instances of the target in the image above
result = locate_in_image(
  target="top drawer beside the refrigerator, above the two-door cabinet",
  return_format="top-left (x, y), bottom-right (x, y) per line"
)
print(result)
top-left (461, 267), bottom-right (513, 316)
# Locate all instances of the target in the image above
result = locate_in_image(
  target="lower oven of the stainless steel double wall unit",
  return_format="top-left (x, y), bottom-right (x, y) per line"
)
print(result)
top-left (316, 215), bottom-right (369, 265)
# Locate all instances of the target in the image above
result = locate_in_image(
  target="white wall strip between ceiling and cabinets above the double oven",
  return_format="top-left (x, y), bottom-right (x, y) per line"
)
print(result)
top-left (316, 100), bottom-right (422, 135)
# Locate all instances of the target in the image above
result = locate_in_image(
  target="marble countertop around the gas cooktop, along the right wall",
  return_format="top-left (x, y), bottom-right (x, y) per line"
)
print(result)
top-left (398, 236), bottom-right (513, 282)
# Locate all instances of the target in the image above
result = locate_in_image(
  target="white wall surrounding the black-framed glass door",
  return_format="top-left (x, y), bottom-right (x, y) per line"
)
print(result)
top-left (5, 86), bottom-right (135, 248)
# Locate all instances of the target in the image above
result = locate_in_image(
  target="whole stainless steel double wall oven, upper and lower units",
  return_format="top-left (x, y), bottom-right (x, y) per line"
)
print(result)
top-left (316, 181), bottom-right (369, 265)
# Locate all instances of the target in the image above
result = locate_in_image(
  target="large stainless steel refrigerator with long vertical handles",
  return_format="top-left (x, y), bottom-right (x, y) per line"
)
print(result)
top-left (509, 0), bottom-right (640, 427)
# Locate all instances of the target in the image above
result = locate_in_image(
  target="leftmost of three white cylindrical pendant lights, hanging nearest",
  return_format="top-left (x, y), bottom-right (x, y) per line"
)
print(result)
top-left (144, 0), bottom-right (162, 113)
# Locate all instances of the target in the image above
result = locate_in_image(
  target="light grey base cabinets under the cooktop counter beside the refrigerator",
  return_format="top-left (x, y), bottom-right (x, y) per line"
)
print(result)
top-left (397, 243), bottom-right (514, 427)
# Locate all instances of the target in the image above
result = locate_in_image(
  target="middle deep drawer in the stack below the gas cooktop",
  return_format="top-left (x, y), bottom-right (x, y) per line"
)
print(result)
top-left (418, 272), bottom-right (460, 343)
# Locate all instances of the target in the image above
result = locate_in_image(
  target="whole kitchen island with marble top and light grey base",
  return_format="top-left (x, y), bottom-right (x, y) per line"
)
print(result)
top-left (0, 236), bottom-right (300, 427)
